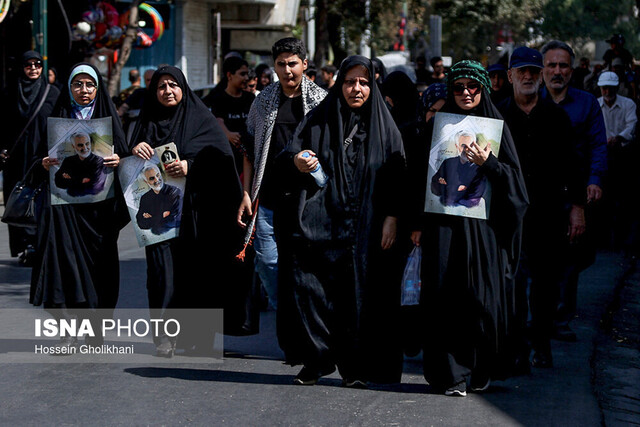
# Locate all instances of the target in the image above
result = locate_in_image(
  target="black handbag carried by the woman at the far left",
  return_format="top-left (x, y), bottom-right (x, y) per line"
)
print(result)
top-left (2, 161), bottom-right (47, 228)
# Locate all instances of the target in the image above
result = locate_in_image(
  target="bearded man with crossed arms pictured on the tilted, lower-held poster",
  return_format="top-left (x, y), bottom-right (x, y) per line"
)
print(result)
top-left (136, 165), bottom-right (182, 235)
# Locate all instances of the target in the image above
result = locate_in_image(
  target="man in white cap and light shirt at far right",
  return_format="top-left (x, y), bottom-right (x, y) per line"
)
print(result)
top-left (598, 70), bottom-right (638, 251)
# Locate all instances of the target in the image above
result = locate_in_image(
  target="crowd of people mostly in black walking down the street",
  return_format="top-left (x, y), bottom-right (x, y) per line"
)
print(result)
top-left (0, 31), bottom-right (639, 396)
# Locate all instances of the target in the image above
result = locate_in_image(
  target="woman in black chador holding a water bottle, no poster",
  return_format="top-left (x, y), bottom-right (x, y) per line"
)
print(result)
top-left (275, 56), bottom-right (405, 387)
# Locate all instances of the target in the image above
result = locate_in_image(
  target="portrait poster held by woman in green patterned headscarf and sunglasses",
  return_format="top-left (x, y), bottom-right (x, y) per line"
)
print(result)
top-left (425, 113), bottom-right (503, 219)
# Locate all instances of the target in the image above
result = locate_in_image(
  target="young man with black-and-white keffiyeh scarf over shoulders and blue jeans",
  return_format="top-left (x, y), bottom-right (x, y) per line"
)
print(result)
top-left (238, 38), bottom-right (326, 308)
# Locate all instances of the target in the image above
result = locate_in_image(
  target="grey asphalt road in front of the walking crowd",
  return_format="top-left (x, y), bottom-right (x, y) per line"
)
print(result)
top-left (0, 219), bottom-right (623, 426)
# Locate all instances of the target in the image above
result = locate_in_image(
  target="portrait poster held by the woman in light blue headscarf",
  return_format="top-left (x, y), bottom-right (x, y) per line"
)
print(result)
top-left (47, 117), bottom-right (115, 205)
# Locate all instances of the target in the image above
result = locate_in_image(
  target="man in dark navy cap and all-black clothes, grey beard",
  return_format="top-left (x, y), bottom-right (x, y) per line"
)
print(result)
top-left (498, 46), bottom-right (586, 368)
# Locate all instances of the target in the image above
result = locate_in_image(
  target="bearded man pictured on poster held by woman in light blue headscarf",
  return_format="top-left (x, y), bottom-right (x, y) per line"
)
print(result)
top-left (55, 132), bottom-right (107, 197)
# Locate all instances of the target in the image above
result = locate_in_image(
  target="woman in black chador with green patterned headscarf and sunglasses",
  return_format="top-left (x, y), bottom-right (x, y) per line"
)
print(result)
top-left (411, 61), bottom-right (528, 396)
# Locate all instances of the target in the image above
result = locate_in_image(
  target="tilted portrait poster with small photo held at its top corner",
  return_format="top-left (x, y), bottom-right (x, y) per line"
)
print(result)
top-left (118, 143), bottom-right (186, 247)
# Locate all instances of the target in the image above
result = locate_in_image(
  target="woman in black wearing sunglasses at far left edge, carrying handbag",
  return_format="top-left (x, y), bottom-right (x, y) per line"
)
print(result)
top-left (0, 50), bottom-right (60, 265)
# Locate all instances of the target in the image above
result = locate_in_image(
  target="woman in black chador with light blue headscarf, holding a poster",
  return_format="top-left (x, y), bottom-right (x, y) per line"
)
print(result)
top-left (30, 63), bottom-right (128, 345)
